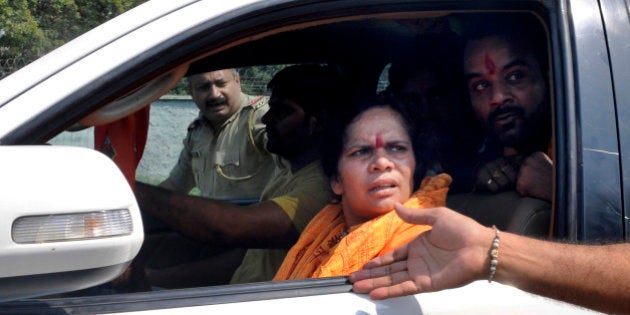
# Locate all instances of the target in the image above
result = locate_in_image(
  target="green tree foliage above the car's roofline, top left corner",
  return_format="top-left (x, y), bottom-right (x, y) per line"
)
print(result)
top-left (0, 0), bottom-right (146, 78)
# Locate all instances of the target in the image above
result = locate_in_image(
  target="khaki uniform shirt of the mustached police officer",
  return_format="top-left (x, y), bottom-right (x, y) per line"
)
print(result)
top-left (161, 93), bottom-right (276, 201)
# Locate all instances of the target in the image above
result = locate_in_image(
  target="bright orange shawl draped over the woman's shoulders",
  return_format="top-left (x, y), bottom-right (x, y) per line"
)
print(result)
top-left (273, 174), bottom-right (451, 280)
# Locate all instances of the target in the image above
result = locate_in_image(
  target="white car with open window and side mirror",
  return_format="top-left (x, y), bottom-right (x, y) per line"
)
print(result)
top-left (0, 0), bottom-right (630, 314)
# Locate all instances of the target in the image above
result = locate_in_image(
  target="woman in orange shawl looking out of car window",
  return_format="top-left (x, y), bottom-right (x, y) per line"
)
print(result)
top-left (274, 98), bottom-right (451, 280)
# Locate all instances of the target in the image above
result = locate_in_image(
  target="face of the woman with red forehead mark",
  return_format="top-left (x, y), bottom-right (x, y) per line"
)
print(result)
top-left (331, 107), bottom-right (416, 226)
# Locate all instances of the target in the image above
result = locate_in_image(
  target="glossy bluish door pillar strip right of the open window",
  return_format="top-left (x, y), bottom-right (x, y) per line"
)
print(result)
top-left (569, 1), bottom-right (622, 240)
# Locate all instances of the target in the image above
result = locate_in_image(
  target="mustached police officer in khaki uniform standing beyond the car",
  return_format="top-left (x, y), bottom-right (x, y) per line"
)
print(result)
top-left (160, 69), bottom-right (276, 200)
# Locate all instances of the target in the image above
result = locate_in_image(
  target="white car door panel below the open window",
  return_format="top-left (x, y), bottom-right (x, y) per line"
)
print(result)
top-left (0, 278), bottom-right (597, 315)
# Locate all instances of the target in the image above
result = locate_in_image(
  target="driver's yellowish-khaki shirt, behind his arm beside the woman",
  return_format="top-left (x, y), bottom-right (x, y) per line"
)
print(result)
top-left (230, 161), bottom-right (333, 283)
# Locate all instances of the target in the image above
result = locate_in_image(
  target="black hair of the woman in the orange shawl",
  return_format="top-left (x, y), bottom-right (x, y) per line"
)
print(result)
top-left (322, 93), bottom-right (437, 190)
